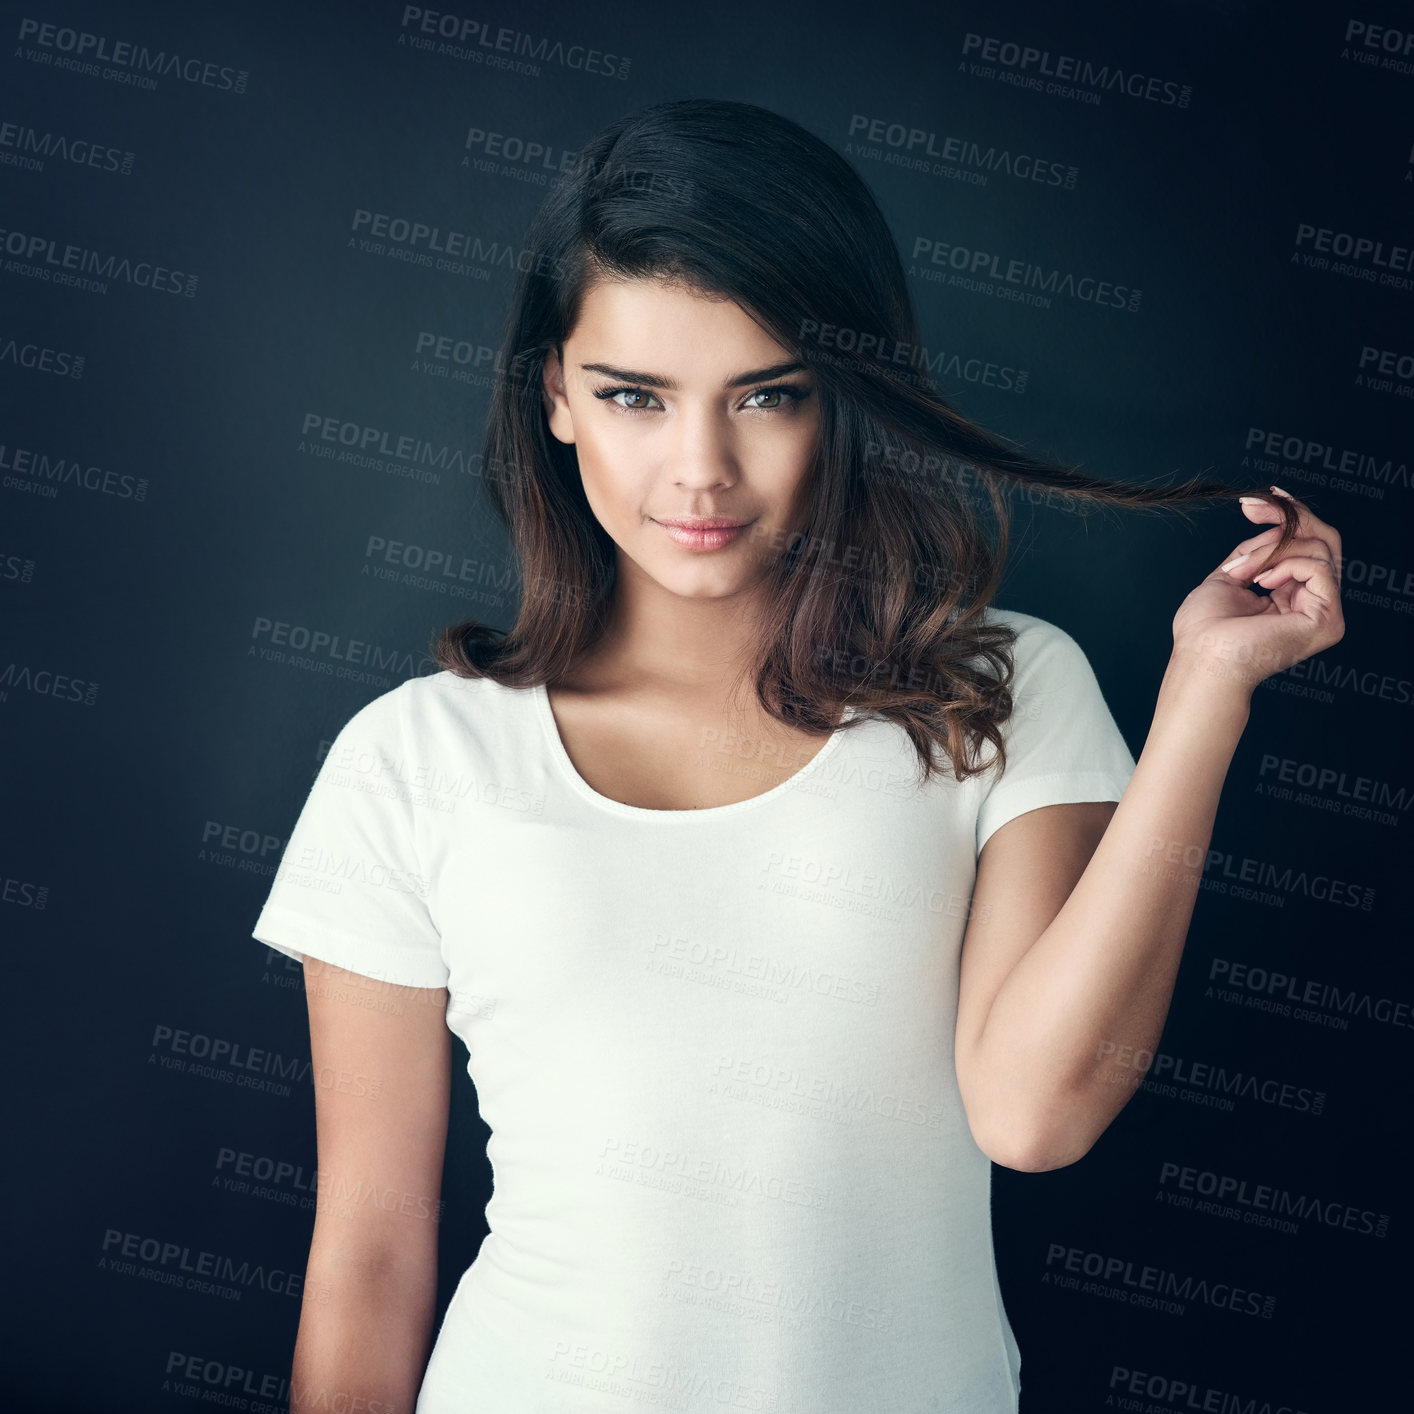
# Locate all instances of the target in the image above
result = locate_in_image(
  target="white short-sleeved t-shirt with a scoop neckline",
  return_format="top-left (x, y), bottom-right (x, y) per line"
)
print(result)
top-left (253, 608), bottom-right (1134, 1414)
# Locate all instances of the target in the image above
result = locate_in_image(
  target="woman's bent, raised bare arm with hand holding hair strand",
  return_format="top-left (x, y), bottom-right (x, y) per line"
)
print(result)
top-left (956, 501), bottom-right (1345, 1171)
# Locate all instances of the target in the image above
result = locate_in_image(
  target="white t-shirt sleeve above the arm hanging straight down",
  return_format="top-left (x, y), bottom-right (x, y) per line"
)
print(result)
top-left (252, 683), bottom-right (451, 987)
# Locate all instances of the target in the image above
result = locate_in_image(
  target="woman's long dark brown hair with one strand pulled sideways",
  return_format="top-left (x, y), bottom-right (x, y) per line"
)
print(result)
top-left (433, 99), bottom-right (1298, 781)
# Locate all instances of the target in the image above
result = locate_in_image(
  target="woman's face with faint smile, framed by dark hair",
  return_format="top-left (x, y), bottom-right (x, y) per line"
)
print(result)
top-left (544, 280), bottom-right (820, 598)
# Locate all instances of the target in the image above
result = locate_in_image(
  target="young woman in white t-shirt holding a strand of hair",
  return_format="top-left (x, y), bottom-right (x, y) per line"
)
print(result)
top-left (255, 100), bottom-right (1343, 1414)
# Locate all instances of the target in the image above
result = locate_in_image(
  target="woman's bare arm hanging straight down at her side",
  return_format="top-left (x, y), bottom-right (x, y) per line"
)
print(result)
top-left (290, 957), bottom-right (451, 1414)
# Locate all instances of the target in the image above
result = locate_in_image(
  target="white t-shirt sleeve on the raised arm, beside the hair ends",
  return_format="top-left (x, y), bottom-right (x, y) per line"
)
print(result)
top-left (977, 614), bottom-right (1135, 855)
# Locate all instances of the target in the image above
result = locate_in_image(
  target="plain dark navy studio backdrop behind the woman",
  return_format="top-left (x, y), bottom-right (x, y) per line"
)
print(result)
top-left (0, 0), bottom-right (1414, 1414)
